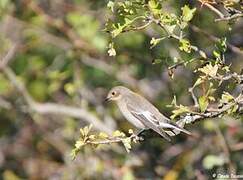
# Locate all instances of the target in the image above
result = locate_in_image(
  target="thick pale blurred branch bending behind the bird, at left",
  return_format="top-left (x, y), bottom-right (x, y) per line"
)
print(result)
top-left (3, 67), bottom-right (112, 134)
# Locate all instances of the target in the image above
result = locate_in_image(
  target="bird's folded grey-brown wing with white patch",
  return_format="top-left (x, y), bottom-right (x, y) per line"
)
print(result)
top-left (127, 103), bottom-right (171, 141)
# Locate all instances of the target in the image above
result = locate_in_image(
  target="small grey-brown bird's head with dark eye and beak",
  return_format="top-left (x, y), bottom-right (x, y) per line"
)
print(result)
top-left (105, 86), bottom-right (130, 101)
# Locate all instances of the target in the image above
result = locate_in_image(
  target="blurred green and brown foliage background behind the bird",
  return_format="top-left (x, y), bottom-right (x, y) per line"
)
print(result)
top-left (0, 0), bottom-right (243, 180)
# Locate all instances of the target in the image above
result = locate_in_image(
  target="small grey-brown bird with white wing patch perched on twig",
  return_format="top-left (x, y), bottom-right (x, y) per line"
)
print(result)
top-left (106, 86), bottom-right (191, 141)
